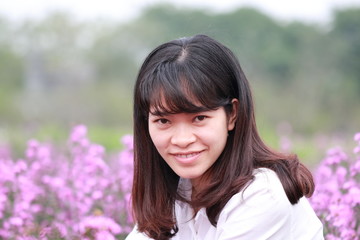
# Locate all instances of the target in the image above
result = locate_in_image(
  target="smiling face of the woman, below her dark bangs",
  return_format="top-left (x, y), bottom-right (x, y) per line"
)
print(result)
top-left (148, 100), bottom-right (237, 187)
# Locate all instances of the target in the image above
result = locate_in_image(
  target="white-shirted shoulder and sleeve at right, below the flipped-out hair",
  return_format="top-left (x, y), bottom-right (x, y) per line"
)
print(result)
top-left (218, 168), bottom-right (323, 239)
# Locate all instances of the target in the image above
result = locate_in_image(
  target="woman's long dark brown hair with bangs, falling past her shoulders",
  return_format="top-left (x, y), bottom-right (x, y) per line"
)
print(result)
top-left (132, 35), bottom-right (314, 240)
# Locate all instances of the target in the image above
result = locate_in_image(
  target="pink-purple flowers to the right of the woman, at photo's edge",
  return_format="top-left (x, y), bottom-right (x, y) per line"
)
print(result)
top-left (310, 133), bottom-right (360, 240)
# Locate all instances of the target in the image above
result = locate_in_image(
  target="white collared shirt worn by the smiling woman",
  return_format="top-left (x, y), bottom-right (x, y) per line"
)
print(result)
top-left (126, 168), bottom-right (324, 240)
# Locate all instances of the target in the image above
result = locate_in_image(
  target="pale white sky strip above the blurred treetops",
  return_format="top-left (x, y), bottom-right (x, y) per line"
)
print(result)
top-left (0, 0), bottom-right (360, 23)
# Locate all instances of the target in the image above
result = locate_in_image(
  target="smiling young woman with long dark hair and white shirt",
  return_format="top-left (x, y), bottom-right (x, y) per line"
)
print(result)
top-left (126, 35), bottom-right (323, 240)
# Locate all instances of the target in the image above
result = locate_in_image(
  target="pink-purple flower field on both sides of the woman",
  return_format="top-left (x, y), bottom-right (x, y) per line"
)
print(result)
top-left (0, 125), bottom-right (360, 240)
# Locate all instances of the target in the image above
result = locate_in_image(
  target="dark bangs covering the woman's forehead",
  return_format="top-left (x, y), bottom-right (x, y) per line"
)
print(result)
top-left (142, 62), bottom-right (230, 115)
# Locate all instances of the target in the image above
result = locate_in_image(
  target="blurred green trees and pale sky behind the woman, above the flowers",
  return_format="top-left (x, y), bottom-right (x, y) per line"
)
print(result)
top-left (0, 0), bottom-right (360, 166)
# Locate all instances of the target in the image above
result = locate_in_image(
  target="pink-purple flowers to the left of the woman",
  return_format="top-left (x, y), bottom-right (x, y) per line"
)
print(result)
top-left (0, 125), bottom-right (133, 240)
